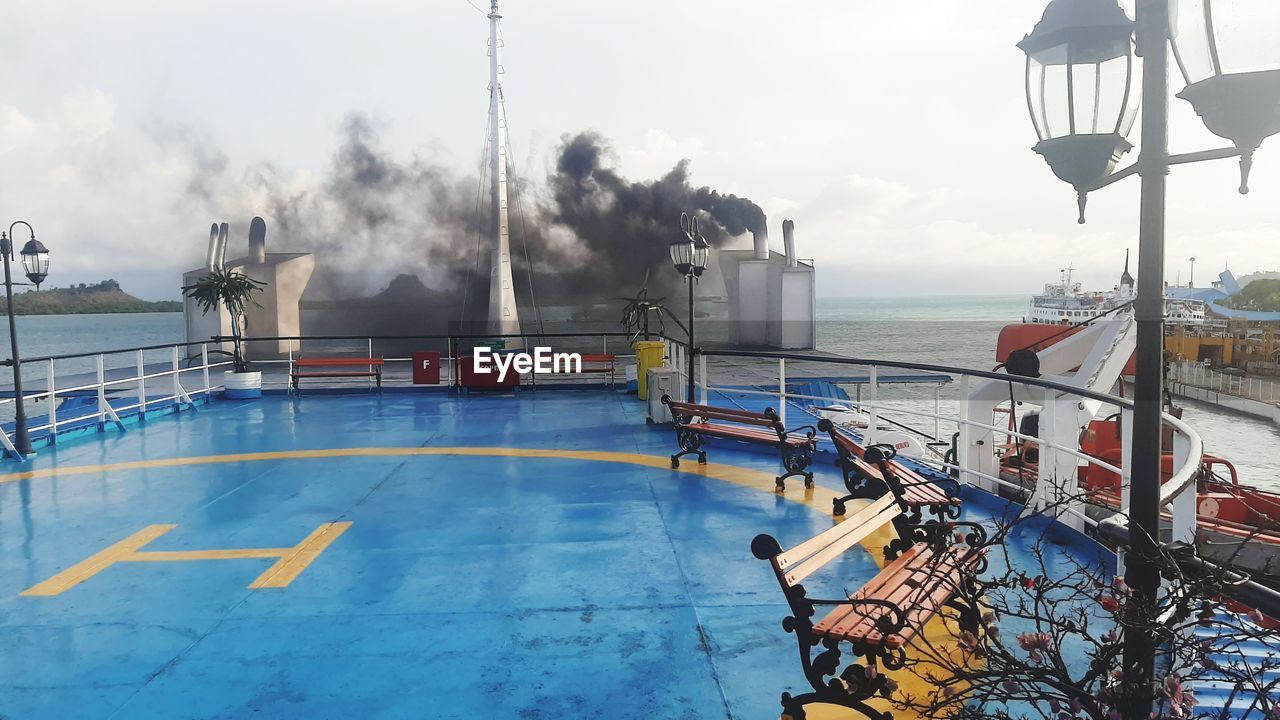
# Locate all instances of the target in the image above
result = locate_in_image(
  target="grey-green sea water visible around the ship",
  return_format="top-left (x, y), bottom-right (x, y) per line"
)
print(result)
top-left (0, 304), bottom-right (1280, 489)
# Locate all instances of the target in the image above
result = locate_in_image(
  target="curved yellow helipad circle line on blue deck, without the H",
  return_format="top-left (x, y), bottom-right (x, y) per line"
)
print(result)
top-left (0, 447), bottom-right (950, 720)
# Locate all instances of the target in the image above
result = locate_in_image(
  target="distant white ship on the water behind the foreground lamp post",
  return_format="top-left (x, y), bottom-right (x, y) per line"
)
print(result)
top-left (1025, 254), bottom-right (1207, 325)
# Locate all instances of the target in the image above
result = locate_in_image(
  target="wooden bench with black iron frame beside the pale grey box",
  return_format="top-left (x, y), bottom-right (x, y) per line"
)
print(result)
top-left (662, 395), bottom-right (818, 492)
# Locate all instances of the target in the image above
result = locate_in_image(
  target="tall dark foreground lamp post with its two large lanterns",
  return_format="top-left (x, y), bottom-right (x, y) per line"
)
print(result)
top-left (1019, 0), bottom-right (1280, 720)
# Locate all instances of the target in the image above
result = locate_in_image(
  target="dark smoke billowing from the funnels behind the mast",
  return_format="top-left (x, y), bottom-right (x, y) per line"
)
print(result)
top-left (239, 115), bottom-right (765, 331)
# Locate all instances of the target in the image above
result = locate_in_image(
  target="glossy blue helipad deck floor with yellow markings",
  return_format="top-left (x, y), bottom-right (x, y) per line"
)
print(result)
top-left (0, 389), bottom-right (1097, 719)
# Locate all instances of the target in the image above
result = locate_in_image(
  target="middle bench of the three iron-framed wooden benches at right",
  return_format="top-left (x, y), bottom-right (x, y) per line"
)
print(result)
top-left (818, 419), bottom-right (960, 523)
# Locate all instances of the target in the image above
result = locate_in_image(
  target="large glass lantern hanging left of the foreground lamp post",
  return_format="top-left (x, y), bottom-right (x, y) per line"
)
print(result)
top-left (1018, 0), bottom-right (1138, 224)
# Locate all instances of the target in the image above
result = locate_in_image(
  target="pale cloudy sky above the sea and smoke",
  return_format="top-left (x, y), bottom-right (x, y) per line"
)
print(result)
top-left (0, 0), bottom-right (1280, 300)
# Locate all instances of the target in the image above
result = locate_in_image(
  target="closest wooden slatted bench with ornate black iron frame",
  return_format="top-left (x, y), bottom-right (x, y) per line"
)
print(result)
top-left (751, 484), bottom-right (987, 720)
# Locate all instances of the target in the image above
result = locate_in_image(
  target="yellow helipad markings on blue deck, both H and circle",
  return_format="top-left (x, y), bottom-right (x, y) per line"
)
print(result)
top-left (0, 447), bottom-right (951, 720)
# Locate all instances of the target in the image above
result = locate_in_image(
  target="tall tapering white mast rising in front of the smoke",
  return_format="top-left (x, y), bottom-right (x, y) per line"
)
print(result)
top-left (488, 0), bottom-right (520, 338)
